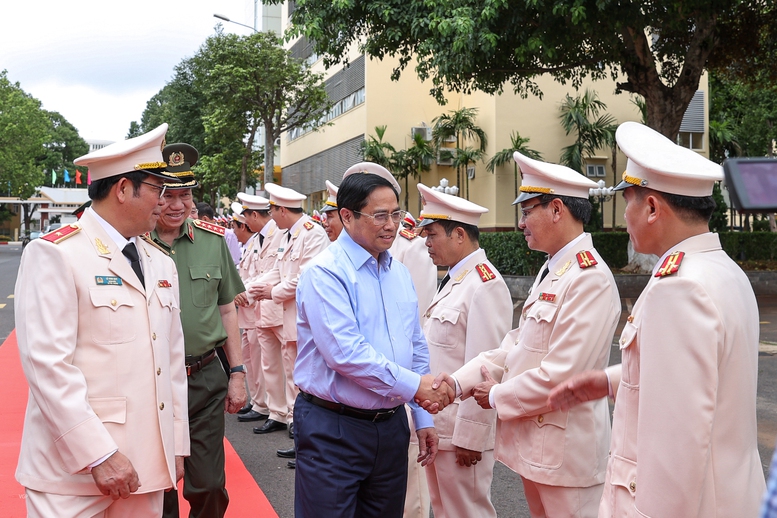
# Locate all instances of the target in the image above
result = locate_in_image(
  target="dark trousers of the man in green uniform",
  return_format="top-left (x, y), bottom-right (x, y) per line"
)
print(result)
top-left (162, 362), bottom-right (229, 518)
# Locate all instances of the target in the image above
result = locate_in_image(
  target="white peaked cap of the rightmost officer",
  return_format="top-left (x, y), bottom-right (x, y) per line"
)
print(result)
top-left (615, 122), bottom-right (723, 198)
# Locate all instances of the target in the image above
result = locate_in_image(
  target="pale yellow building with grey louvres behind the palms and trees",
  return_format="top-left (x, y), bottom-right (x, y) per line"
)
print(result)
top-left (280, 5), bottom-right (709, 231)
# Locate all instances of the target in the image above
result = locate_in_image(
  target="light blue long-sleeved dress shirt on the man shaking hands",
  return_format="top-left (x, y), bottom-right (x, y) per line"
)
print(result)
top-left (294, 231), bottom-right (434, 429)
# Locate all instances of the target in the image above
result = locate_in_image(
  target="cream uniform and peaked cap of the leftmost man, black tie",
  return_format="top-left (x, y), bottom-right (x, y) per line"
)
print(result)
top-left (15, 124), bottom-right (189, 516)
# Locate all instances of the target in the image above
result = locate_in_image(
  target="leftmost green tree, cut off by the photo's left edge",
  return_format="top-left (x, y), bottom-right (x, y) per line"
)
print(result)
top-left (0, 70), bottom-right (51, 229)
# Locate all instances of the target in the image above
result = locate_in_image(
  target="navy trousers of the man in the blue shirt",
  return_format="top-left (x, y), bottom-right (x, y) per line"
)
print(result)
top-left (294, 396), bottom-right (410, 518)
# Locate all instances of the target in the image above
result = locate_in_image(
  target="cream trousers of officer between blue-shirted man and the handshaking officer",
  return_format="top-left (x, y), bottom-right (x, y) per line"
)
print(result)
top-left (426, 450), bottom-right (496, 518)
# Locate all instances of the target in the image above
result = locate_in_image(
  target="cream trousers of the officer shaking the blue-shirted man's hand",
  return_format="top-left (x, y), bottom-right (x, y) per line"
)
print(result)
top-left (521, 477), bottom-right (604, 518)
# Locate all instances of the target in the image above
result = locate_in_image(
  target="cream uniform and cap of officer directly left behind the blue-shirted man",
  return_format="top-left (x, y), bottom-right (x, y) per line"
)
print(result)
top-left (265, 184), bottom-right (329, 423)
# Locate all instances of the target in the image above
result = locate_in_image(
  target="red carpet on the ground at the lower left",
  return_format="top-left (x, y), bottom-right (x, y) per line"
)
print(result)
top-left (0, 331), bottom-right (278, 518)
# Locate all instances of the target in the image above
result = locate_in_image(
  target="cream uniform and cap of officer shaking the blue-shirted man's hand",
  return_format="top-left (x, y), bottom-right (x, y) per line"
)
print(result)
top-left (453, 153), bottom-right (621, 516)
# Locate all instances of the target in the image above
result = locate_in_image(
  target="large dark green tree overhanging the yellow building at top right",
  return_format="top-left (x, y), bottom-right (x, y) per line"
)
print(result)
top-left (282, 0), bottom-right (777, 138)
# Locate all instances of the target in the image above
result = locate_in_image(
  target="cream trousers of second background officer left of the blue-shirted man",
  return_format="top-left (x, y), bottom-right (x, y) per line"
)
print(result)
top-left (256, 326), bottom-right (293, 423)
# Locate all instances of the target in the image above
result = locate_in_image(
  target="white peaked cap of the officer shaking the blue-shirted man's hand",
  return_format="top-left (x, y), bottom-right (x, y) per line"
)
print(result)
top-left (513, 151), bottom-right (599, 205)
